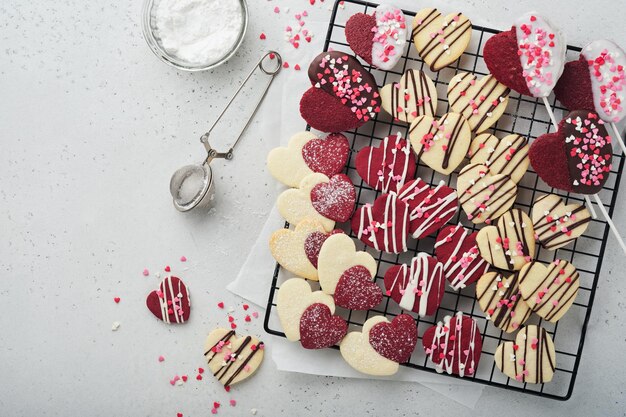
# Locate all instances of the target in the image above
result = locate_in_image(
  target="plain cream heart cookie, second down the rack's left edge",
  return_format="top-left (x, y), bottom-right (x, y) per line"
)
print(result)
top-left (276, 173), bottom-right (335, 232)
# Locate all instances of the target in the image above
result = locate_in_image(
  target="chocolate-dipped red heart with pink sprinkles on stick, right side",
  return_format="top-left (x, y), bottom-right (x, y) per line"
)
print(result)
top-left (528, 110), bottom-right (613, 194)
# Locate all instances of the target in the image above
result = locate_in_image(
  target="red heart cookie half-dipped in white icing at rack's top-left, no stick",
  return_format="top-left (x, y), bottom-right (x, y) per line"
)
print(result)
top-left (346, 4), bottom-right (408, 71)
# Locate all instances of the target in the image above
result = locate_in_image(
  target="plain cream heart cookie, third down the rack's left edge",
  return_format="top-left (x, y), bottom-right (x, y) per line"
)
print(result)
top-left (270, 219), bottom-right (326, 281)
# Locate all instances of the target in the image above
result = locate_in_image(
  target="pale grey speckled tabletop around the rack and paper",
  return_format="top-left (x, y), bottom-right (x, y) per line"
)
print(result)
top-left (0, 0), bottom-right (626, 416)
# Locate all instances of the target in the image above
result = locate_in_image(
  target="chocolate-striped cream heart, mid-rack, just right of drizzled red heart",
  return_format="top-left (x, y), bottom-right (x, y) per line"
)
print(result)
top-left (456, 164), bottom-right (517, 224)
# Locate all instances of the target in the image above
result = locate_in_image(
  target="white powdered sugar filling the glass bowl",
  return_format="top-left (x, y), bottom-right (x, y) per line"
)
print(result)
top-left (142, 0), bottom-right (248, 71)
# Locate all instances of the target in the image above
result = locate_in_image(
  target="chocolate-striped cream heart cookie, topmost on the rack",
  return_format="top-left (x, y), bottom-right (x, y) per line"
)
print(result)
top-left (412, 9), bottom-right (472, 71)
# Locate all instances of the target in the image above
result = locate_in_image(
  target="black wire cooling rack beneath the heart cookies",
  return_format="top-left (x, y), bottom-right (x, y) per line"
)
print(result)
top-left (265, 0), bottom-right (624, 400)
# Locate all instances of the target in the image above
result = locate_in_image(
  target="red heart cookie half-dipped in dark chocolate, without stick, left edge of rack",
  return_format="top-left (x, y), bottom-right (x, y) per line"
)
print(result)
top-left (300, 51), bottom-right (380, 132)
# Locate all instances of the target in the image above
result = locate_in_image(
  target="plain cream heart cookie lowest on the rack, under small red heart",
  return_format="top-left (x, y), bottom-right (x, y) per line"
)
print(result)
top-left (339, 316), bottom-right (400, 376)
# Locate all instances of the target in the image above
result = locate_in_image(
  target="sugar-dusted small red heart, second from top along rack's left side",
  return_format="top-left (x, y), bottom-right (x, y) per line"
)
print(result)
top-left (311, 174), bottom-right (356, 222)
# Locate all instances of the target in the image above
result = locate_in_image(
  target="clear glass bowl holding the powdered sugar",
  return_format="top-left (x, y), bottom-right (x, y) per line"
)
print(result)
top-left (141, 0), bottom-right (248, 72)
